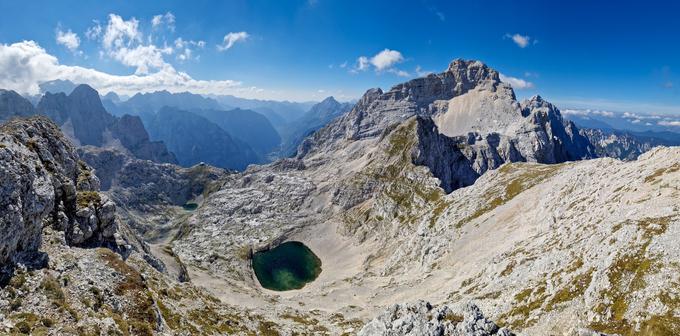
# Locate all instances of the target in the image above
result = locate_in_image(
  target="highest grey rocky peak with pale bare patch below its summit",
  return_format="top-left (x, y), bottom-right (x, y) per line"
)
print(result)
top-left (298, 60), bottom-right (595, 192)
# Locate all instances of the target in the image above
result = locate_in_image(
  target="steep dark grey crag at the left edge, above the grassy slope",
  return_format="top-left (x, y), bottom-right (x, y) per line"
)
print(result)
top-left (0, 117), bottom-right (126, 263)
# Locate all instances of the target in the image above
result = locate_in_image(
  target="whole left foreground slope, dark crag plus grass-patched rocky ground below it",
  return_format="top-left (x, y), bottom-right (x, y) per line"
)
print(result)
top-left (0, 116), bottom-right (318, 335)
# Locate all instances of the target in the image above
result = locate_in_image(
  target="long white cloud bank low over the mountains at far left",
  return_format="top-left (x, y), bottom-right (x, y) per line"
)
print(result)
top-left (0, 41), bottom-right (244, 95)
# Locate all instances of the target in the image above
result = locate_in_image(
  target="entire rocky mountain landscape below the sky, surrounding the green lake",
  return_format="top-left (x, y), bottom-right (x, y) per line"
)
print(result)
top-left (0, 59), bottom-right (680, 336)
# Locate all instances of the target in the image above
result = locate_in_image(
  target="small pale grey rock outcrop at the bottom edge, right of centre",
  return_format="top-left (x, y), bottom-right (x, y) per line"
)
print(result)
top-left (358, 301), bottom-right (514, 336)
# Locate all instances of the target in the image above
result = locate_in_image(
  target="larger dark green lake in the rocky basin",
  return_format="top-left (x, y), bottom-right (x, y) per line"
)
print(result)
top-left (253, 241), bottom-right (321, 291)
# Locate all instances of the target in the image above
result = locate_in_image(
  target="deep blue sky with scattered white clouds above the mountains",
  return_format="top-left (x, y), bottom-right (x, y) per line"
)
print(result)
top-left (0, 0), bottom-right (680, 114)
